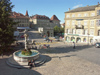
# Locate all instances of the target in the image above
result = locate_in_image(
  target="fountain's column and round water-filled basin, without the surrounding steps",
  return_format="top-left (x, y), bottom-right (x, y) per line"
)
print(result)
top-left (13, 30), bottom-right (39, 62)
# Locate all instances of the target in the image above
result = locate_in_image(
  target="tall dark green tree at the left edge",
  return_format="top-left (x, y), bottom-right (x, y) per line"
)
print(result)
top-left (0, 0), bottom-right (15, 50)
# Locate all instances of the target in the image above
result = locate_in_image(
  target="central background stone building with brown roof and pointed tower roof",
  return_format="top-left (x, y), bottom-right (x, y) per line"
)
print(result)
top-left (30, 14), bottom-right (60, 29)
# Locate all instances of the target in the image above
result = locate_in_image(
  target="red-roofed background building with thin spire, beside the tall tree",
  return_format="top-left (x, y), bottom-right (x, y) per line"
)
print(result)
top-left (10, 11), bottom-right (30, 29)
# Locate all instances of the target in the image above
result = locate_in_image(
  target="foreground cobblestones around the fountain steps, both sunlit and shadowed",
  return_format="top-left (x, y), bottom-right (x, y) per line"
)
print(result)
top-left (0, 53), bottom-right (100, 75)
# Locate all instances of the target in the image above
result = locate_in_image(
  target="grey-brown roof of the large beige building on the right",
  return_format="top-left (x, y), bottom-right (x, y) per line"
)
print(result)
top-left (65, 5), bottom-right (98, 13)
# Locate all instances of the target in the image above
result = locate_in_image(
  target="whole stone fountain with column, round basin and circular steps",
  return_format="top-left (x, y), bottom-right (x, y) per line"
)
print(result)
top-left (6, 30), bottom-right (47, 68)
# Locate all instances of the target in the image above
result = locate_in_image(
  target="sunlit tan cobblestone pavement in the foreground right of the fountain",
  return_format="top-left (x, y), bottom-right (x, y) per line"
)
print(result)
top-left (36, 54), bottom-right (100, 75)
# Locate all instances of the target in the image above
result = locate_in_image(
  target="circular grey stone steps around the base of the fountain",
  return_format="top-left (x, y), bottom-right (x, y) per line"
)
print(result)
top-left (6, 55), bottom-right (46, 68)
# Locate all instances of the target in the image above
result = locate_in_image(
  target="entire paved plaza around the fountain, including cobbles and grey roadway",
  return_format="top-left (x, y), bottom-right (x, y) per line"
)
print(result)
top-left (0, 31), bottom-right (100, 75)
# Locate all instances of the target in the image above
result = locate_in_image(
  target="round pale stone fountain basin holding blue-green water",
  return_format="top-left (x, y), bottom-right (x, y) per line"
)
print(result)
top-left (13, 50), bottom-right (39, 62)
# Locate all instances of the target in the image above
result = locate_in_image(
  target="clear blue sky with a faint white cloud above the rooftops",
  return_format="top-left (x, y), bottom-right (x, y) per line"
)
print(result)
top-left (10, 0), bottom-right (100, 23)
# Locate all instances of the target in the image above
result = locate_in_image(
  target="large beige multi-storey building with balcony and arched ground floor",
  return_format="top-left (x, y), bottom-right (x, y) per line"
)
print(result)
top-left (64, 3), bottom-right (100, 44)
